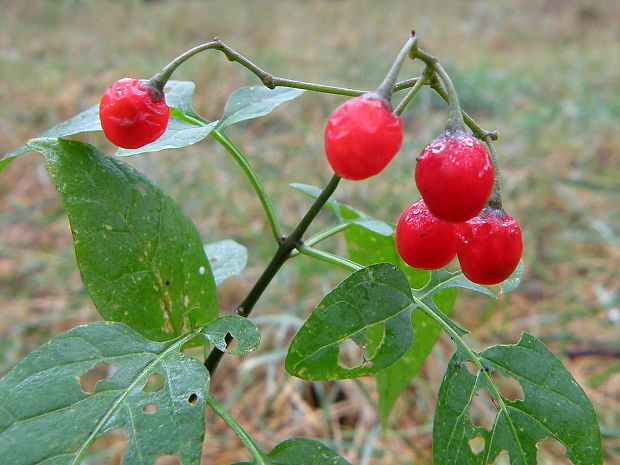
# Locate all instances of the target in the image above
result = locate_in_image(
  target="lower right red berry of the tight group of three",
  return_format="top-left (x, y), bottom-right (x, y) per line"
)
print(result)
top-left (456, 207), bottom-right (523, 284)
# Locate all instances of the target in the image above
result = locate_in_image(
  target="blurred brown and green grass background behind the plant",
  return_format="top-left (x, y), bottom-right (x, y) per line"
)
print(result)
top-left (0, 0), bottom-right (620, 465)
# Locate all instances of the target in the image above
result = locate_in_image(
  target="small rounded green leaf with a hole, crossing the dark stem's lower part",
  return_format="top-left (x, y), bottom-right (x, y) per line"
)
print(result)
top-left (200, 315), bottom-right (260, 355)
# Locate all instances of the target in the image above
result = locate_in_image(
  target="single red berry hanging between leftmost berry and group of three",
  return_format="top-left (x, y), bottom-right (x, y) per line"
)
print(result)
top-left (325, 93), bottom-right (403, 180)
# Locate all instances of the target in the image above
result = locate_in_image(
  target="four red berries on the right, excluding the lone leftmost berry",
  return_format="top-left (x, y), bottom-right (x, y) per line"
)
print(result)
top-left (325, 93), bottom-right (523, 284)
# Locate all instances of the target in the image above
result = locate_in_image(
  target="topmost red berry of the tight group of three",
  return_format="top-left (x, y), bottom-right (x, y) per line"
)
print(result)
top-left (415, 130), bottom-right (494, 223)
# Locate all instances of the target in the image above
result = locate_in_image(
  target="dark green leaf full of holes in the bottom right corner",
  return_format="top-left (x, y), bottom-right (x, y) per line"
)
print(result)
top-left (433, 333), bottom-right (602, 465)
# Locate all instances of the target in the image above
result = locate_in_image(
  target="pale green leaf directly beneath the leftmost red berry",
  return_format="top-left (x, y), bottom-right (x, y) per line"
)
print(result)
top-left (116, 117), bottom-right (217, 157)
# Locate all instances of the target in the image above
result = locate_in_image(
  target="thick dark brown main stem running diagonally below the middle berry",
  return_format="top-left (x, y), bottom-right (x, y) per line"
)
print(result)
top-left (204, 175), bottom-right (341, 374)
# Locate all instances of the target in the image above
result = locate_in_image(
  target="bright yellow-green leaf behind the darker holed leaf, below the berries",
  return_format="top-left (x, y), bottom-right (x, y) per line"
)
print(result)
top-left (344, 224), bottom-right (456, 428)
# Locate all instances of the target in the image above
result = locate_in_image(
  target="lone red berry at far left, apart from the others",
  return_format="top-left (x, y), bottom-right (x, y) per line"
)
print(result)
top-left (99, 78), bottom-right (170, 149)
